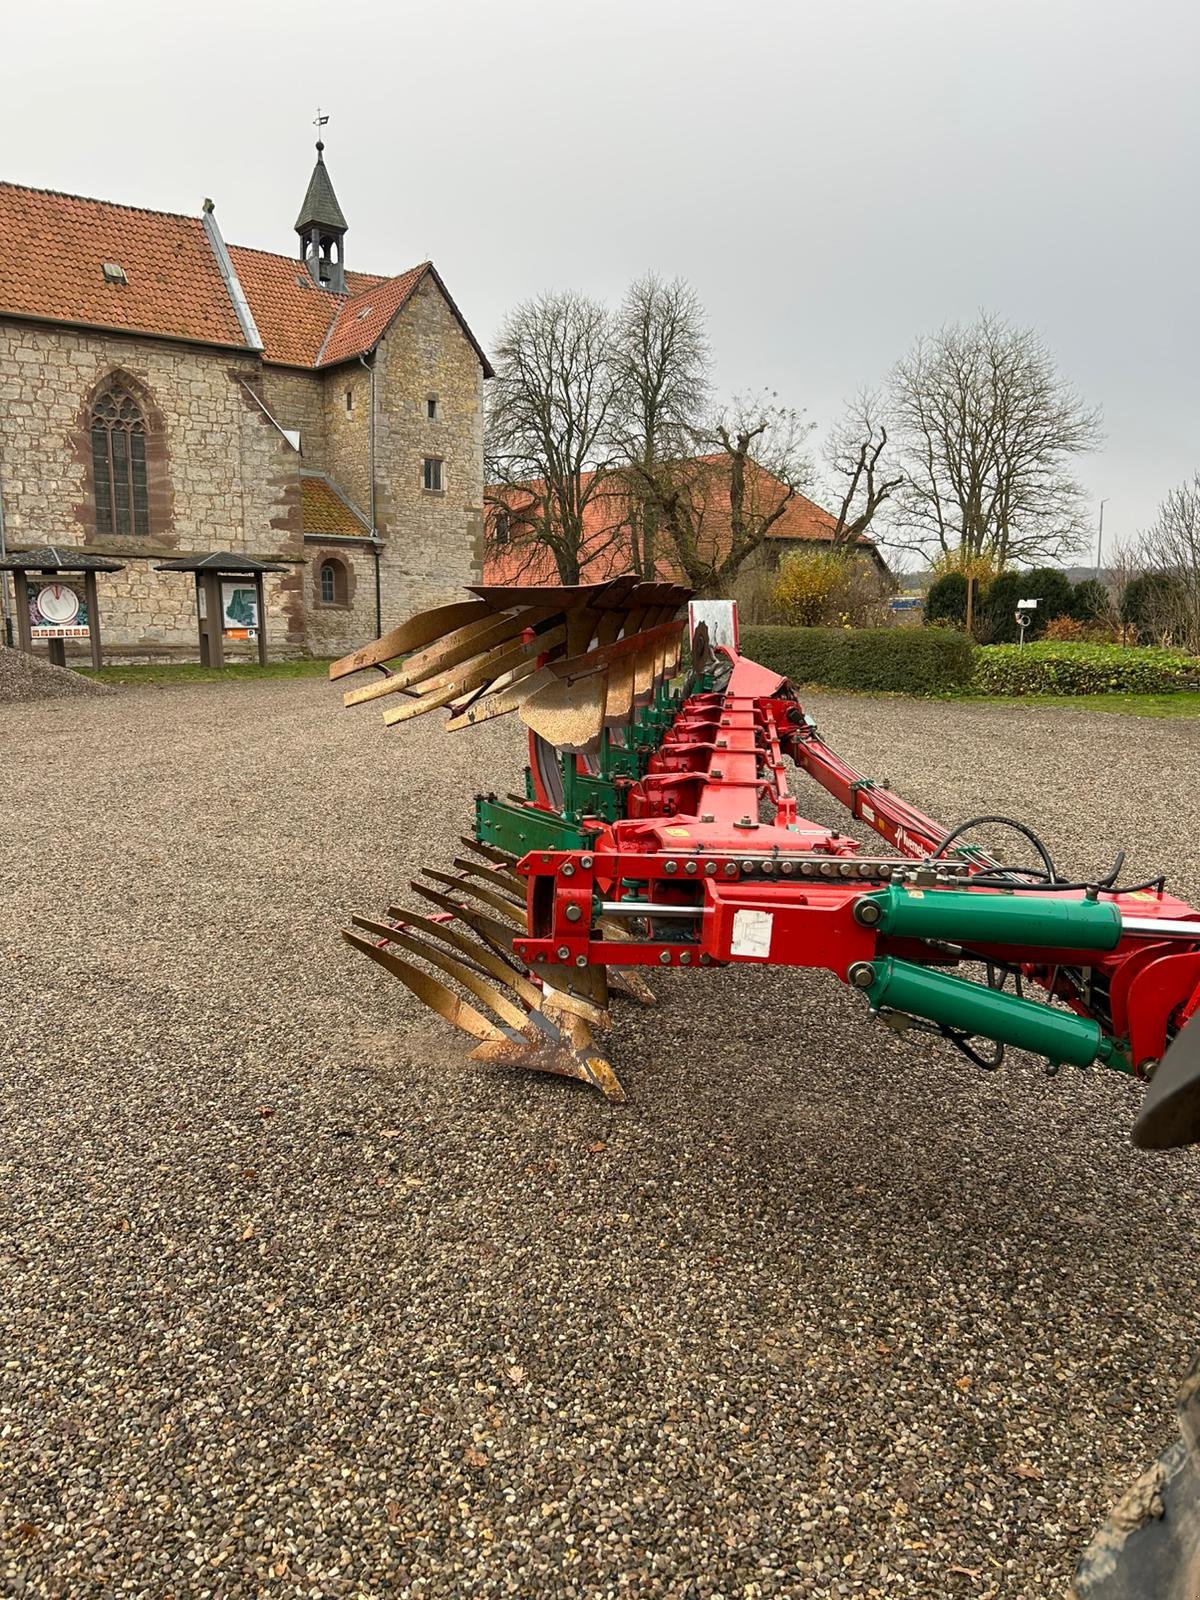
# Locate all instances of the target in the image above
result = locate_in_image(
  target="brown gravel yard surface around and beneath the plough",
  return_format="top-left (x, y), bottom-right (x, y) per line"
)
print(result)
top-left (0, 682), bottom-right (1200, 1600)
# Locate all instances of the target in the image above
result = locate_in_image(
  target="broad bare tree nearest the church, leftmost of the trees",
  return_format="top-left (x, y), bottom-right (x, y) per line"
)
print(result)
top-left (485, 294), bottom-right (624, 584)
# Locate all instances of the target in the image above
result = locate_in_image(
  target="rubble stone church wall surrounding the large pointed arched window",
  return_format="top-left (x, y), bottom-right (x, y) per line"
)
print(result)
top-left (0, 322), bottom-right (304, 658)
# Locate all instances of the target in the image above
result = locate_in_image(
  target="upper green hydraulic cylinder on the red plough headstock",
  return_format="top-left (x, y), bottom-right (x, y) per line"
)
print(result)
top-left (854, 883), bottom-right (1122, 950)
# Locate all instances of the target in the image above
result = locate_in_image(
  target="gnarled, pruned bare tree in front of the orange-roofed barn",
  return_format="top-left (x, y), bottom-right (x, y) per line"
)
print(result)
top-left (629, 395), bottom-right (811, 595)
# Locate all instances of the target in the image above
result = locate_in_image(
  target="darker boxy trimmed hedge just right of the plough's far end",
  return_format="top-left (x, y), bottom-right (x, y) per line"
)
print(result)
top-left (739, 627), bottom-right (973, 694)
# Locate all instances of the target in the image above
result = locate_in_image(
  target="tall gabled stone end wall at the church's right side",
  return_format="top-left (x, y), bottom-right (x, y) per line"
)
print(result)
top-left (376, 278), bottom-right (483, 629)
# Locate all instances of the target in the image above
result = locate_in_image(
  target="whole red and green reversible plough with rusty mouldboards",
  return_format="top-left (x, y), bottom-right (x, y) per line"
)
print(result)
top-left (330, 578), bottom-right (1200, 1597)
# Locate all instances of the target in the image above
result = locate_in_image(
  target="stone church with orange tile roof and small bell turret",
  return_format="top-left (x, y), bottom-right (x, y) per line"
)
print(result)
top-left (0, 142), bottom-right (491, 659)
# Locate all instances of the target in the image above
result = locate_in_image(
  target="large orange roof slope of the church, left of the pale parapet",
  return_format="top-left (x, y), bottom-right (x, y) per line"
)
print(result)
top-left (0, 184), bottom-right (246, 349)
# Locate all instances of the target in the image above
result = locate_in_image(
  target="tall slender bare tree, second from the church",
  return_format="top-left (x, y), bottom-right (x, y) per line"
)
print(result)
top-left (613, 272), bottom-right (709, 578)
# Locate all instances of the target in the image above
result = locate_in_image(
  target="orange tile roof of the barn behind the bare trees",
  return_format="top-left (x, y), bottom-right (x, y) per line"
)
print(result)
top-left (483, 456), bottom-right (878, 584)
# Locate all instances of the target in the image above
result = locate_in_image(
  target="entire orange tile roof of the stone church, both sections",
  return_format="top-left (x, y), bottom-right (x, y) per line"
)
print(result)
top-left (0, 182), bottom-right (491, 378)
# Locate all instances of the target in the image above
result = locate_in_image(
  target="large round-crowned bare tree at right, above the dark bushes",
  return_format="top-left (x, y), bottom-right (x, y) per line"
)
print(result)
top-left (888, 315), bottom-right (1101, 566)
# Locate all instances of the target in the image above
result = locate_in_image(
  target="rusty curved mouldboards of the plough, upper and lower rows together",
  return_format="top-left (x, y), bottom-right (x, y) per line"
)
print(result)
top-left (330, 579), bottom-right (686, 1099)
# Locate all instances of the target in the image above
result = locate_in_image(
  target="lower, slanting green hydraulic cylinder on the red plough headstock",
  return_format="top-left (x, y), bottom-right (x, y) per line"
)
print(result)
top-left (850, 958), bottom-right (1122, 1067)
